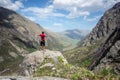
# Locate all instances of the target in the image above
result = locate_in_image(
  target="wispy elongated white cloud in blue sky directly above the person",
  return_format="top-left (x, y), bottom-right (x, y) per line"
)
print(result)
top-left (22, 5), bottom-right (65, 18)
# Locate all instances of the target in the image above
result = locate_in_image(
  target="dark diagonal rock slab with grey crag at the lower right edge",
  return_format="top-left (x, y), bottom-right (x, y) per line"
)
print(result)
top-left (89, 26), bottom-right (120, 74)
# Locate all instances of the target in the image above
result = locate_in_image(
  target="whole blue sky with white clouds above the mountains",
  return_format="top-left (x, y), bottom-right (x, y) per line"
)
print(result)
top-left (0, 0), bottom-right (120, 32)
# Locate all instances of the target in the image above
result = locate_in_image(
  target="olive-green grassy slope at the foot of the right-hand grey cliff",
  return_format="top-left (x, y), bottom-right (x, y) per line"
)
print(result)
top-left (63, 39), bottom-right (102, 67)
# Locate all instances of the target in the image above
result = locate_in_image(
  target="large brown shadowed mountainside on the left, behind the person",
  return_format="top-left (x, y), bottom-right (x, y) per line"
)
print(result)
top-left (0, 7), bottom-right (62, 74)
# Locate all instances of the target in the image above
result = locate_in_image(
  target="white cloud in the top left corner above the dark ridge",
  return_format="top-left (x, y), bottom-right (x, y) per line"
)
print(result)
top-left (0, 0), bottom-right (24, 10)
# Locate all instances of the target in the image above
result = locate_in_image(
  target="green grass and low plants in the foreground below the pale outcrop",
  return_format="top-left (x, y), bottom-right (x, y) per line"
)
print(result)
top-left (34, 57), bottom-right (94, 80)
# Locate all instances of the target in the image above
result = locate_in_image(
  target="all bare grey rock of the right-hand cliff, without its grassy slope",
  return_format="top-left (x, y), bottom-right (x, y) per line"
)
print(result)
top-left (82, 3), bottom-right (120, 74)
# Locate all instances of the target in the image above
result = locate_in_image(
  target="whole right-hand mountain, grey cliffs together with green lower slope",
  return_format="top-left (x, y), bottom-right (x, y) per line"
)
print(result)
top-left (64, 2), bottom-right (120, 74)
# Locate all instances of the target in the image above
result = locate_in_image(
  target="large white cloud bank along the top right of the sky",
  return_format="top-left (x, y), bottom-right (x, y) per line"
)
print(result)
top-left (53, 0), bottom-right (120, 18)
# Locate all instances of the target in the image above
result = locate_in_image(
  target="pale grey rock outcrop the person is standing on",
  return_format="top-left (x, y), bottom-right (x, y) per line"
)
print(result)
top-left (21, 50), bottom-right (67, 76)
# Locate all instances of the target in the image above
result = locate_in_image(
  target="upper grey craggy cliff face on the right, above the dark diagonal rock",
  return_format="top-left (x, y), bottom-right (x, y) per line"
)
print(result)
top-left (79, 3), bottom-right (120, 46)
